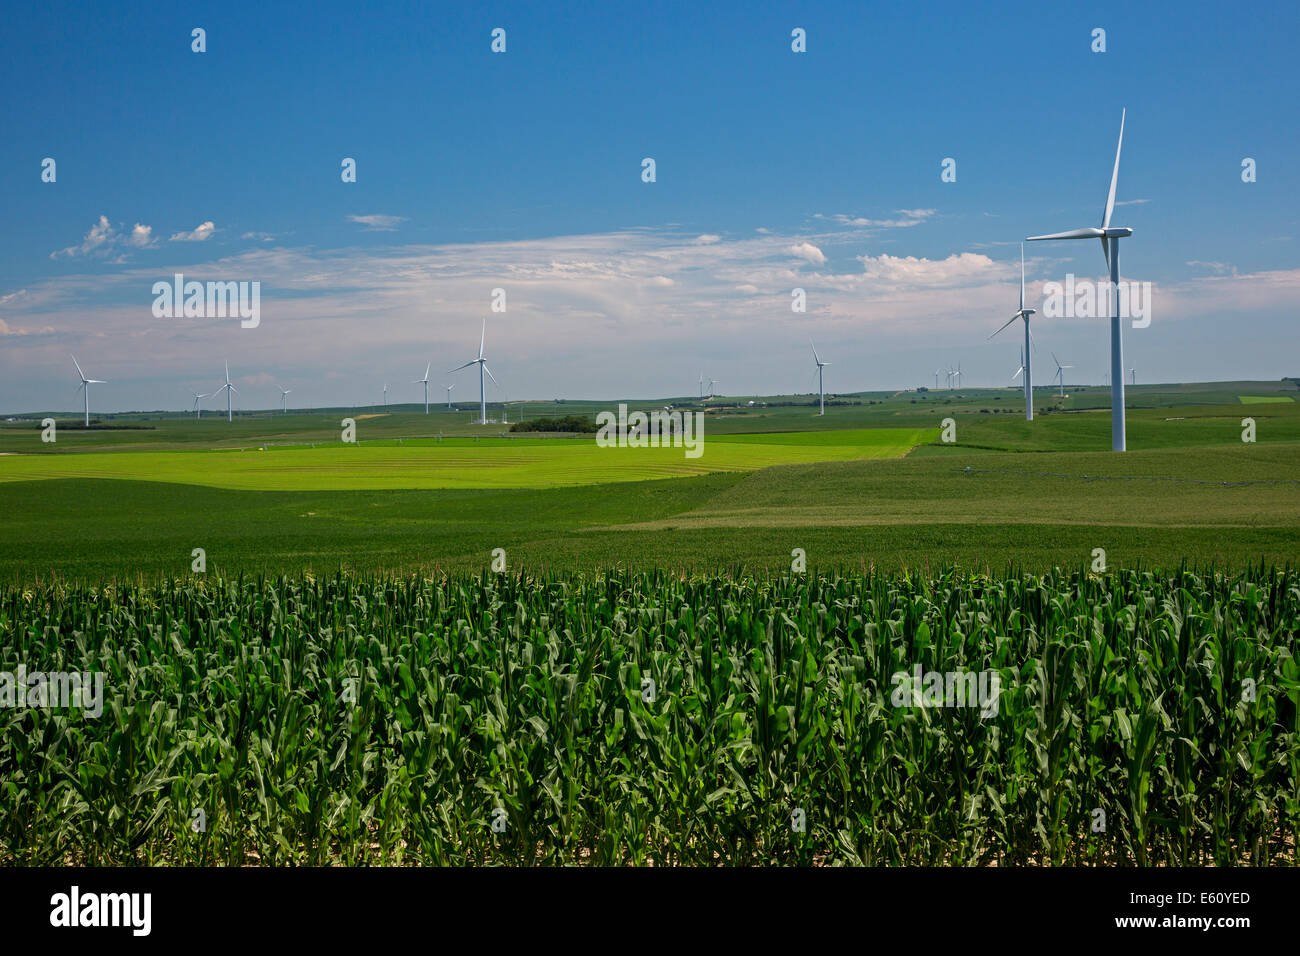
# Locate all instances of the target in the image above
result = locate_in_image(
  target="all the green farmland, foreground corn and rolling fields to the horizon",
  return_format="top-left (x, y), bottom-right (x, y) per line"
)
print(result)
top-left (0, 382), bottom-right (1300, 865)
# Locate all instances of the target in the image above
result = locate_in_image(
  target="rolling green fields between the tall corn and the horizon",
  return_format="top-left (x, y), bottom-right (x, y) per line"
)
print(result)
top-left (0, 382), bottom-right (1300, 583)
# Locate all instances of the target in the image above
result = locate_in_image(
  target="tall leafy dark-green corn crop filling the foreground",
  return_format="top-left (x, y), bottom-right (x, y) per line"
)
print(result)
top-left (0, 567), bottom-right (1300, 866)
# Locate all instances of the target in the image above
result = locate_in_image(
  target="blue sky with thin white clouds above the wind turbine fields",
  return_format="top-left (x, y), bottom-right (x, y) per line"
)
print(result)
top-left (0, 3), bottom-right (1300, 411)
